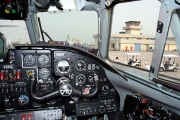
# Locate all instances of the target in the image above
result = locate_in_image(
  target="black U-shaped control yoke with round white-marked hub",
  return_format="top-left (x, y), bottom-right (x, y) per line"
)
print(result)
top-left (30, 74), bottom-right (99, 102)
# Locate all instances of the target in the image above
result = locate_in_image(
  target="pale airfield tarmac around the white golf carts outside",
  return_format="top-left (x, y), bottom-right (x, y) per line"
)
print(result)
top-left (109, 51), bottom-right (180, 79)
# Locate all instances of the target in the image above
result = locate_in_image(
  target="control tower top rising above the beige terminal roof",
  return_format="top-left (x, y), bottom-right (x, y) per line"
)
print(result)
top-left (123, 21), bottom-right (142, 35)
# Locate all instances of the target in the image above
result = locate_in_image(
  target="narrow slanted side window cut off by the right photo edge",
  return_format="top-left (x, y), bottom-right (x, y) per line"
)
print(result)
top-left (158, 10), bottom-right (180, 81)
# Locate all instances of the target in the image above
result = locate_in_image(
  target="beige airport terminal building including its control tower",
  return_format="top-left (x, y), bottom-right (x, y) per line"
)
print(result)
top-left (93, 21), bottom-right (177, 51)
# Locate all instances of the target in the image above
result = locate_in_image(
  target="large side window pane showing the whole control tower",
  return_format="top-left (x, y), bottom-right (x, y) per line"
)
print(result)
top-left (109, 0), bottom-right (161, 69)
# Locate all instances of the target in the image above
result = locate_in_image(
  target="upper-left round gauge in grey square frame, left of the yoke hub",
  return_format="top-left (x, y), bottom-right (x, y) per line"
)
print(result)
top-left (23, 54), bottom-right (36, 66)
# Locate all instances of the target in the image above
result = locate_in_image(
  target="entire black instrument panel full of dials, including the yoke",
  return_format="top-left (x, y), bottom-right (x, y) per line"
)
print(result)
top-left (0, 46), bottom-right (120, 117)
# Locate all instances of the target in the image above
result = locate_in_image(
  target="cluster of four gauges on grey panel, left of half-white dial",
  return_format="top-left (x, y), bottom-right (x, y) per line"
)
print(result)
top-left (21, 50), bottom-right (51, 83)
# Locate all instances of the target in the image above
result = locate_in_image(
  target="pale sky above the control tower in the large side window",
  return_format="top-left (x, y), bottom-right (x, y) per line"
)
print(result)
top-left (112, 0), bottom-right (161, 35)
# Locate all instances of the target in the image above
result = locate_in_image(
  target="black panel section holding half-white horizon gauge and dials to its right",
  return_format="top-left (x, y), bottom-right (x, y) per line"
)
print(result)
top-left (53, 51), bottom-right (103, 87)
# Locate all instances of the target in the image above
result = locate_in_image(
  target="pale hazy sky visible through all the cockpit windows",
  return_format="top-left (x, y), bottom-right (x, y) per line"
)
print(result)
top-left (0, 0), bottom-right (160, 43)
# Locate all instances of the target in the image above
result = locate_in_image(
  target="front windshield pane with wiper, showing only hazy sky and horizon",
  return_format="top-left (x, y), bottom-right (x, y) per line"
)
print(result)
top-left (37, 11), bottom-right (98, 48)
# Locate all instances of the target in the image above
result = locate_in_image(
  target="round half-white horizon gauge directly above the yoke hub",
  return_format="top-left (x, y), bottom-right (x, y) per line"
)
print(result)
top-left (57, 60), bottom-right (70, 73)
